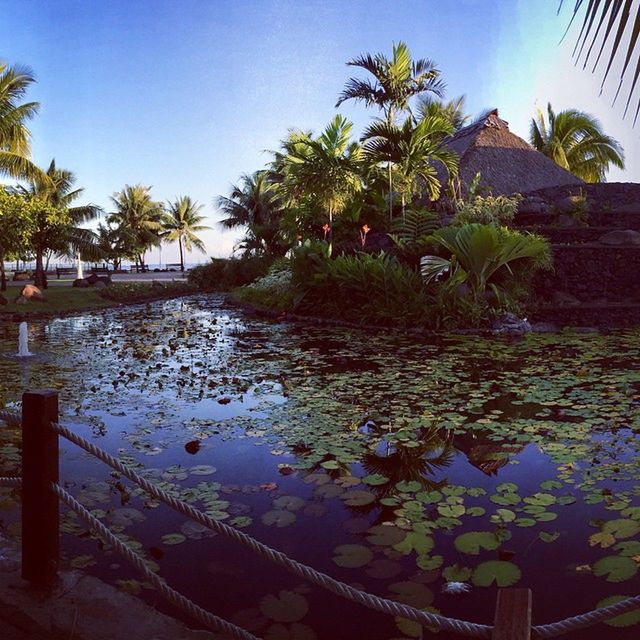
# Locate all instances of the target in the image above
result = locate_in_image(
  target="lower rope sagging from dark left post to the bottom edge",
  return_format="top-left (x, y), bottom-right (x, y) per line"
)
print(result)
top-left (50, 482), bottom-right (259, 640)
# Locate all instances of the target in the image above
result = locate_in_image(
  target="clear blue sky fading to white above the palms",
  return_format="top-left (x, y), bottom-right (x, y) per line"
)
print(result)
top-left (0, 0), bottom-right (640, 263)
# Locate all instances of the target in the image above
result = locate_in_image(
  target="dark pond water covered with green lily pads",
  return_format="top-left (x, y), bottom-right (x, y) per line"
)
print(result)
top-left (0, 296), bottom-right (640, 640)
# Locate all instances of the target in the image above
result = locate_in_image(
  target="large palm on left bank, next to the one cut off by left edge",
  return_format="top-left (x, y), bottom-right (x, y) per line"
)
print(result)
top-left (19, 160), bottom-right (102, 287)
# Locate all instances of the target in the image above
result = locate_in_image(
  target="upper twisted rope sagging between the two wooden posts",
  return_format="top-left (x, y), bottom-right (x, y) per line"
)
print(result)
top-left (51, 423), bottom-right (492, 638)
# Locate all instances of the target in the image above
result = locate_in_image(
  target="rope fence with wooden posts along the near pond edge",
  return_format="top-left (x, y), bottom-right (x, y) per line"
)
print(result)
top-left (0, 392), bottom-right (640, 640)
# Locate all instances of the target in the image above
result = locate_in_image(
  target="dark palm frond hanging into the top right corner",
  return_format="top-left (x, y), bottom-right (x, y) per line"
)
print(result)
top-left (560, 0), bottom-right (640, 124)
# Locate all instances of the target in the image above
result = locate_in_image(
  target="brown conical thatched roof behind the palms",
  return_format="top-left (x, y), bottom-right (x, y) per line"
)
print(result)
top-left (446, 109), bottom-right (582, 195)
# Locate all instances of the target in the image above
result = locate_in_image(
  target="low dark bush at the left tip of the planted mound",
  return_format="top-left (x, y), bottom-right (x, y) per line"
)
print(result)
top-left (189, 257), bottom-right (273, 291)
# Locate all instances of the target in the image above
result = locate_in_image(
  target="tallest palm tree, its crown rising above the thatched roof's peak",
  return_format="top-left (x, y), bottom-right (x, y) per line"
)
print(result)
top-left (336, 42), bottom-right (444, 219)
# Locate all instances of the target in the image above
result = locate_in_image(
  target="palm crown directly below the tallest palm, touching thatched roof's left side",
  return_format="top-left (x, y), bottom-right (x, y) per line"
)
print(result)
top-left (363, 113), bottom-right (458, 217)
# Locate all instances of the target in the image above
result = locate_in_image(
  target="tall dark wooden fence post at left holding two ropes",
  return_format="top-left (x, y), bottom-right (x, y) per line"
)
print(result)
top-left (22, 390), bottom-right (60, 587)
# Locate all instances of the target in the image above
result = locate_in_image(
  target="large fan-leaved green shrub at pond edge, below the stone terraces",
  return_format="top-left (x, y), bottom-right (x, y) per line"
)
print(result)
top-left (421, 224), bottom-right (551, 324)
